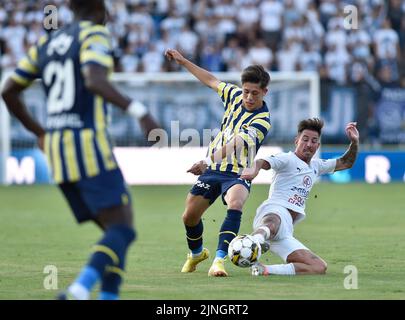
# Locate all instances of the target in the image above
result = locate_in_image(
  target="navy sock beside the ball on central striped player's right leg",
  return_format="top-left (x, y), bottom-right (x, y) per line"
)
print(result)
top-left (216, 209), bottom-right (242, 258)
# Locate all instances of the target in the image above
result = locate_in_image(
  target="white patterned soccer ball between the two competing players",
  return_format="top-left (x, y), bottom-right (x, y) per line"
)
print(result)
top-left (228, 234), bottom-right (262, 268)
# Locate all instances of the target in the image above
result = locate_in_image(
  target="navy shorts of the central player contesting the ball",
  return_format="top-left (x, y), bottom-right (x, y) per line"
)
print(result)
top-left (190, 169), bottom-right (251, 205)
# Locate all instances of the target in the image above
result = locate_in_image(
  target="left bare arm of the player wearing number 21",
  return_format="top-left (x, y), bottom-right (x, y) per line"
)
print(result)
top-left (1, 78), bottom-right (45, 150)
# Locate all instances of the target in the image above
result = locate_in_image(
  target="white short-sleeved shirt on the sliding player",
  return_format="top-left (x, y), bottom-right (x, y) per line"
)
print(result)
top-left (263, 151), bottom-right (336, 223)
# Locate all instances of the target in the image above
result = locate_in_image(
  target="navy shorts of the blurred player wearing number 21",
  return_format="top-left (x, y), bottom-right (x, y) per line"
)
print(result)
top-left (59, 169), bottom-right (131, 223)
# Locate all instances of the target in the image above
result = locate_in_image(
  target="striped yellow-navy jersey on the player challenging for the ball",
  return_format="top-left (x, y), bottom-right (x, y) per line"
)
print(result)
top-left (208, 82), bottom-right (271, 174)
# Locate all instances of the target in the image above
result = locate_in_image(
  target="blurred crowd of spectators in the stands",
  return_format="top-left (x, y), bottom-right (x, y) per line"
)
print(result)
top-left (0, 0), bottom-right (405, 86)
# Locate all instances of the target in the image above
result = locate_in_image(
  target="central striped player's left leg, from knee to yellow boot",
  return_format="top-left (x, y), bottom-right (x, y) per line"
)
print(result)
top-left (181, 193), bottom-right (210, 273)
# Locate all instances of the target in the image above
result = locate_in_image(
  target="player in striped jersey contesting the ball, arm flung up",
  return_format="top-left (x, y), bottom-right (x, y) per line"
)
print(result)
top-left (166, 49), bottom-right (271, 277)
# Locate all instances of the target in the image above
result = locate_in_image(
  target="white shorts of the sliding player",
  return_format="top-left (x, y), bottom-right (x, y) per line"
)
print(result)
top-left (253, 202), bottom-right (309, 262)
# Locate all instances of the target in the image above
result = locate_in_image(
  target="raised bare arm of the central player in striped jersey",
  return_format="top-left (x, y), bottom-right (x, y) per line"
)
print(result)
top-left (165, 49), bottom-right (221, 91)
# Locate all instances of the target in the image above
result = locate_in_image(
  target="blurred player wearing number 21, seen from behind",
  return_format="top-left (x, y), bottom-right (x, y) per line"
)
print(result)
top-left (2, 0), bottom-right (158, 300)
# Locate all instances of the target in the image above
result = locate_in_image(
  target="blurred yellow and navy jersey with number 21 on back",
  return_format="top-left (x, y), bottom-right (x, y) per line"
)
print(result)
top-left (12, 21), bottom-right (118, 183)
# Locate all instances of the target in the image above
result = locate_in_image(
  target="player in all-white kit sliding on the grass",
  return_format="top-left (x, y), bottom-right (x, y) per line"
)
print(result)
top-left (241, 118), bottom-right (359, 275)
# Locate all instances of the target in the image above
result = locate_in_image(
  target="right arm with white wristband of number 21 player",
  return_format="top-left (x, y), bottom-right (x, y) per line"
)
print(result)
top-left (83, 64), bottom-right (160, 136)
